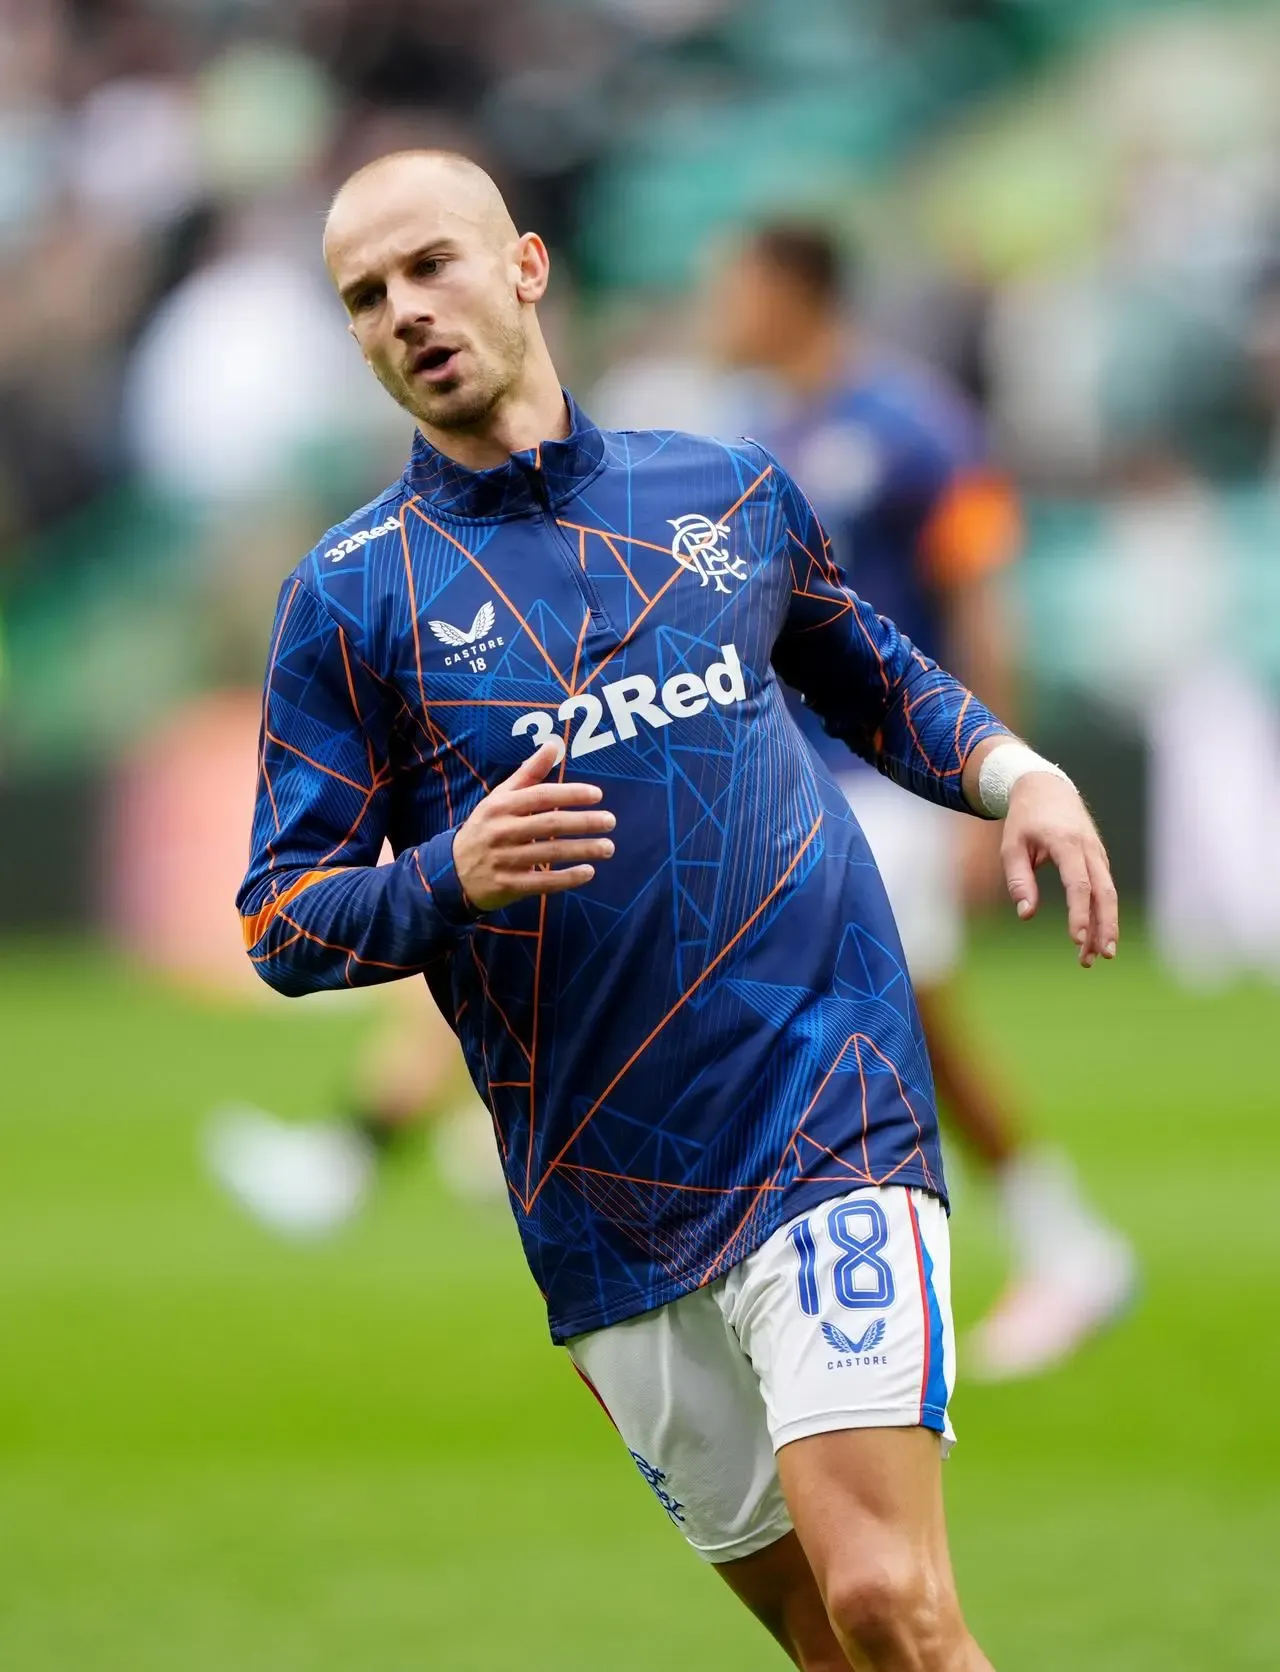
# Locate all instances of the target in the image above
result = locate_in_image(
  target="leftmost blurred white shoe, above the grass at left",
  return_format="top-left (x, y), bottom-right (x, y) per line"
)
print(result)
top-left (204, 1104), bottom-right (378, 1237)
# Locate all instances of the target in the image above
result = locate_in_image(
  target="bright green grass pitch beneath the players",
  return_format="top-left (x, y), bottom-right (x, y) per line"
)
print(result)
top-left (0, 925), bottom-right (1280, 1672)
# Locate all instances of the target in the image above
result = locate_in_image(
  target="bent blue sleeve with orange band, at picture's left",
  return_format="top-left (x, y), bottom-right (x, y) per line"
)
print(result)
top-left (236, 577), bottom-right (471, 997)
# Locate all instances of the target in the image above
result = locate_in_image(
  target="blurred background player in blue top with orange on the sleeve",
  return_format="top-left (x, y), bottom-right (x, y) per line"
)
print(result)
top-left (705, 221), bottom-right (1135, 1379)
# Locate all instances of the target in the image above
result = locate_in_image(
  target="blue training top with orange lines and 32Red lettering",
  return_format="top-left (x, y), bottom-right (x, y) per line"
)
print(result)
top-left (239, 401), bottom-right (1001, 1341)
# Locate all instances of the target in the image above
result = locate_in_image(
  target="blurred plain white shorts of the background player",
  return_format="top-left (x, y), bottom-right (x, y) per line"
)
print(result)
top-left (839, 771), bottom-right (964, 986)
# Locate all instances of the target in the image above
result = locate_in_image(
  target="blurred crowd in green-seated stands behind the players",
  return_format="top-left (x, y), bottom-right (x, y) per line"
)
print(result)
top-left (0, 0), bottom-right (1280, 969)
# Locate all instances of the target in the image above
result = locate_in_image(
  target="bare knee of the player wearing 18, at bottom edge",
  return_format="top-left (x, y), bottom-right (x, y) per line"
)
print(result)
top-left (825, 1553), bottom-right (963, 1672)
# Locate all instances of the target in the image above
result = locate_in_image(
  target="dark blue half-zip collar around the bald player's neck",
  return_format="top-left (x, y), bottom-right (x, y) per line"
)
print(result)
top-left (404, 390), bottom-right (605, 522)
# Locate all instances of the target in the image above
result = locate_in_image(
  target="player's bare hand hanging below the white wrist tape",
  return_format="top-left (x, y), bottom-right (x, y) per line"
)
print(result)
top-left (999, 772), bottom-right (1120, 970)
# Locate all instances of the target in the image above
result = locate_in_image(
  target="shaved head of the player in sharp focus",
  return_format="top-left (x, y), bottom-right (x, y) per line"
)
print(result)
top-left (324, 150), bottom-right (560, 456)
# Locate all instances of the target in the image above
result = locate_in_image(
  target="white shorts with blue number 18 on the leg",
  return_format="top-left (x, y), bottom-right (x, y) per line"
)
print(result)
top-left (568, 1185), bottom-right (956, 1562)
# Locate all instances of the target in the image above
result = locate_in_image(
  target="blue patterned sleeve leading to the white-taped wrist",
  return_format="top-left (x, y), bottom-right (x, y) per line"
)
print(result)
top-left (765, 455), bottom-right (1008, 813)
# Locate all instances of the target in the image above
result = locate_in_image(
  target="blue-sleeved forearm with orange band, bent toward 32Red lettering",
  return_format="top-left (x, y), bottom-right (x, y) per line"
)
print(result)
top-left (237, 831), bottom-right (473, 998)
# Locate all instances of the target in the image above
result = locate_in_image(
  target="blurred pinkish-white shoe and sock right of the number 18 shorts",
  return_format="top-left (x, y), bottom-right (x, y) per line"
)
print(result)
top-left (961, 1154), bottom-right (1138, 1381)
